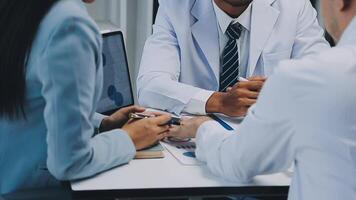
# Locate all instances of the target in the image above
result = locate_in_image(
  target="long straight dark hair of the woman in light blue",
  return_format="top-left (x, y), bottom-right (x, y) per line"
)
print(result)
top-left (0, 0), bottom-right (58, 119)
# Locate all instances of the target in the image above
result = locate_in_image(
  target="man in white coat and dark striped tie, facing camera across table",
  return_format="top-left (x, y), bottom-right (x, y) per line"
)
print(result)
top-left (137, 0), bottom-right (329, 116)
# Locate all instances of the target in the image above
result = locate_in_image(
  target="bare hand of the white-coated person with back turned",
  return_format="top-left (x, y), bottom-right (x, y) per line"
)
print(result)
top-left (167, 117), bottom-right (212, 139)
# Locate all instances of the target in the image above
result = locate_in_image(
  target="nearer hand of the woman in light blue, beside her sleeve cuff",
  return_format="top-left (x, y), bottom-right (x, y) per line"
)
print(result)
top-left (122, 113), bottom-right (171, 150)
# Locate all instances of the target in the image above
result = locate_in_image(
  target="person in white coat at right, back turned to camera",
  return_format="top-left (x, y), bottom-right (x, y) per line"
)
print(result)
top-left (171, 0), bottom-right (356, 200)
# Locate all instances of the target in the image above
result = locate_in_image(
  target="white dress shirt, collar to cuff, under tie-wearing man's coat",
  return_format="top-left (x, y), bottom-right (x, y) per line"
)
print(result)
top-left (184, 0), bottom-right (252, 114)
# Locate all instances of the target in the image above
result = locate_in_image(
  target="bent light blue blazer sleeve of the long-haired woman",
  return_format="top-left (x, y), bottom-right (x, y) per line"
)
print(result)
top-left (38, 19), bottom-right (135, 180)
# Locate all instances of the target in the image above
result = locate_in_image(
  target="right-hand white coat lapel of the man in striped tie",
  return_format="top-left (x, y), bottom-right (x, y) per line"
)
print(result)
top-left (248, 0), bottom-right (280, 76)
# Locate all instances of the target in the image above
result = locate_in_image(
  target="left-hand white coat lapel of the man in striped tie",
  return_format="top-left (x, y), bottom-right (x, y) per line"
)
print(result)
top-left (191, 0), bottom-right (220, 83)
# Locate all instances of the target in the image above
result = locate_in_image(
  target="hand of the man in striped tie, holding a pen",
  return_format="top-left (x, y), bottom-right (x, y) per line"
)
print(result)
top-left (206, 77), bottom-right (266, 117)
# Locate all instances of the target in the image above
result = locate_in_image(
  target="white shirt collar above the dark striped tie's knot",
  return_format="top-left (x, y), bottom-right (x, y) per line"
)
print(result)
top-left (212, 0), bottom-right (252, 33)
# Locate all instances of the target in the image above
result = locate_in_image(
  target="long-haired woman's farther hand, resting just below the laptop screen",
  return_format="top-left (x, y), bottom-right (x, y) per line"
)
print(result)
top-left (100, 106), bottom-right (146, 132)
